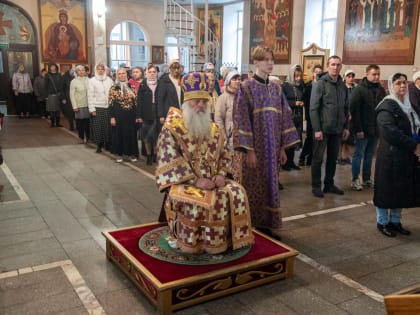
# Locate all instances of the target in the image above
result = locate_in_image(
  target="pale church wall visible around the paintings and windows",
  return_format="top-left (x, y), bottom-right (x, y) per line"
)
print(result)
top-left (4, 0), bottom-right (420, 79)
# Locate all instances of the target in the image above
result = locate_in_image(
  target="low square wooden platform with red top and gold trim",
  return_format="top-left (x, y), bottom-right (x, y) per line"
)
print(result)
top-left (102, 223), bottom-right (298, 314)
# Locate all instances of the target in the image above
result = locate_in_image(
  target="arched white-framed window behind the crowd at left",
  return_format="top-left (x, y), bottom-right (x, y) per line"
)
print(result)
top-left (110, 21), bottom-right (149, 70)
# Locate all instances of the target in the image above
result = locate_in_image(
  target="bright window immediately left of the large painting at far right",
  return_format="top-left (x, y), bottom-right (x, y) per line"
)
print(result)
top-left (303, 0), bottom-right (338, 55)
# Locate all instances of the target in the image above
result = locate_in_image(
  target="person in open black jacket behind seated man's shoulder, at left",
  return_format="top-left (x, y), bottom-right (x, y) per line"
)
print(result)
top-left (157, 59), bottom-right (184, 127)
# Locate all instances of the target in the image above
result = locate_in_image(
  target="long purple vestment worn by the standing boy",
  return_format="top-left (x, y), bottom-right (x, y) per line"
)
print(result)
top-left (233, 79), bottom-right (300, 229)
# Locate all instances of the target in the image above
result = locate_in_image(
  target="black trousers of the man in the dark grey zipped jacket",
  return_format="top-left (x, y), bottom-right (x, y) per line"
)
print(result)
top-left (311, 134), bottom-right (341, 188)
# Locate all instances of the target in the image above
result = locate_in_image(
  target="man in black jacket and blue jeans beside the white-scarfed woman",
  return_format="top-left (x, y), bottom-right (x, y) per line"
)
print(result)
top-left (350, 65), bottom-right (386, 191)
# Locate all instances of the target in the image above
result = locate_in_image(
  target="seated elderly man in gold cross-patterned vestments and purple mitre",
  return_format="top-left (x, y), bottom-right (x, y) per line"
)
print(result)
top-left (156, 72), bottom-right (254, 254)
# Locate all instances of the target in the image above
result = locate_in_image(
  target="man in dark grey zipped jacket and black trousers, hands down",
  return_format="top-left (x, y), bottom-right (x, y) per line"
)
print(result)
top-left (309, 56), bottom-right (349, 198)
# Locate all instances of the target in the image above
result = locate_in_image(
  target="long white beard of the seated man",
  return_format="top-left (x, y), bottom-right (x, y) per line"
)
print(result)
top-left (182, 101), bottom-right (211, 140)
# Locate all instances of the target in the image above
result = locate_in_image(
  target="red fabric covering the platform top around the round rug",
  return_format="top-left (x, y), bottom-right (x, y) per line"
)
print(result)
top-left (109, 224), bottom-right (289, 284)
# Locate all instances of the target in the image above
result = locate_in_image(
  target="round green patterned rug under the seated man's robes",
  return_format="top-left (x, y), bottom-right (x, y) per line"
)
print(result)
top-left (139, 226), bottom-right (251, 265)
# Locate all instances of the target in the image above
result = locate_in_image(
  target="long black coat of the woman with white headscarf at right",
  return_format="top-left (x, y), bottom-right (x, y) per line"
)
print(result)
top-left (373, 99), bottom-right (419, 209)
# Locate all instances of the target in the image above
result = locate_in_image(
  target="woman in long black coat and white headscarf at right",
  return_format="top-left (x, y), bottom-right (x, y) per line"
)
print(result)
top-left (373, 73), bottom-right (420, 237)
